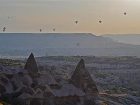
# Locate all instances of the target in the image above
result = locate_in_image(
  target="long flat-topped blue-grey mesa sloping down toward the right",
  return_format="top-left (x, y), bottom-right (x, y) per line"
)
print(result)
top-left (0, 33), bottom-right (140, 56)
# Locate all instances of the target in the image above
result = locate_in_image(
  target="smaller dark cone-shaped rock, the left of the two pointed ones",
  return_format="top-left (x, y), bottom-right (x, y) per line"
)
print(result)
top-left (24, 53), bottom-right (38, 76)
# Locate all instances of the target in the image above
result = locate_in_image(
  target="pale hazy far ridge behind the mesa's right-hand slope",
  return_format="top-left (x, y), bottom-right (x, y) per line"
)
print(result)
top-left (102, 34), bottom-right (140, 45)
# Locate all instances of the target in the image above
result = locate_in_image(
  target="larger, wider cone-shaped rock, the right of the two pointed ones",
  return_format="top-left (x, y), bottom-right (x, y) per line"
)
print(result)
top-left (71, 59), bottom-right (98, 97)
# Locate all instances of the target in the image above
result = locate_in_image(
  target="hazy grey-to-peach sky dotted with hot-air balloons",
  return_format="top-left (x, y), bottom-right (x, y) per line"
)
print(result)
top-left (0, 0), bottom-right (140, 34)
